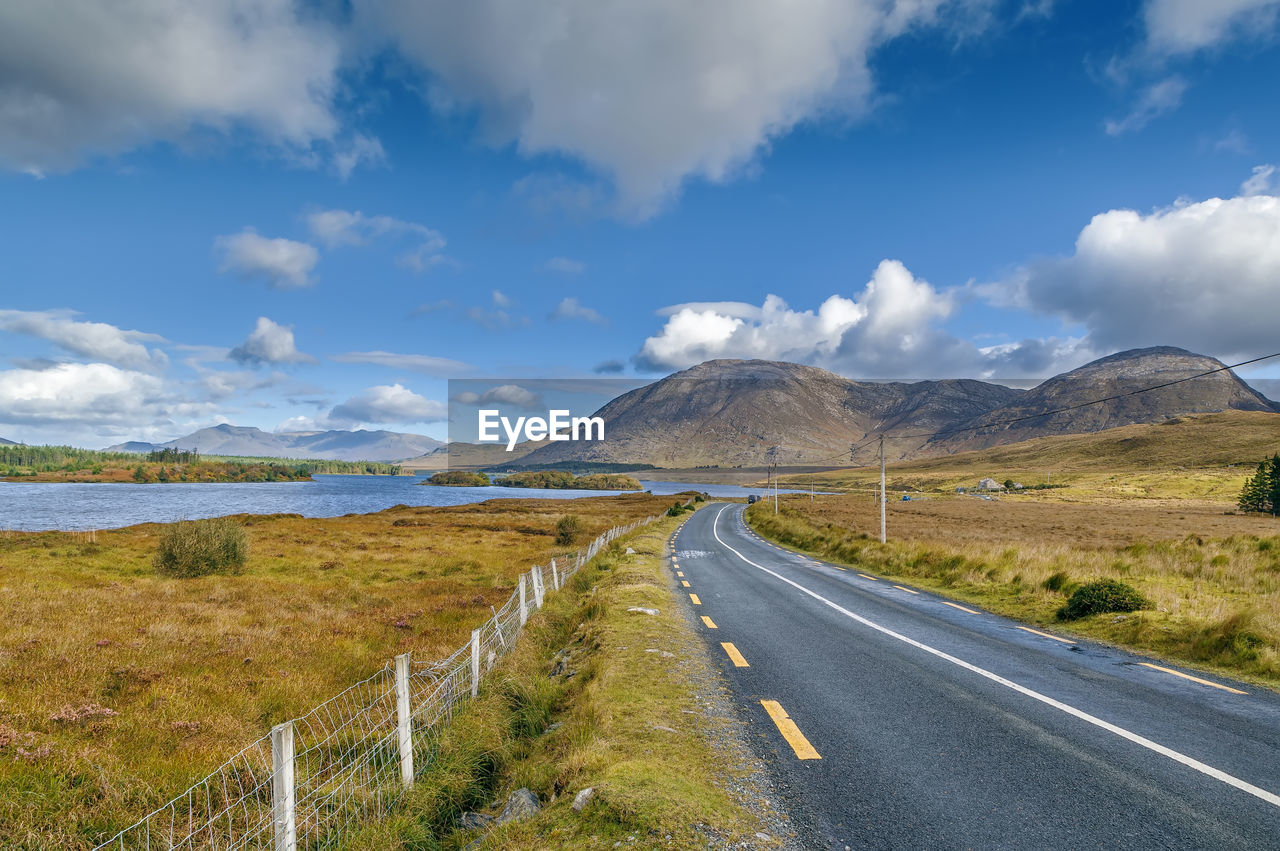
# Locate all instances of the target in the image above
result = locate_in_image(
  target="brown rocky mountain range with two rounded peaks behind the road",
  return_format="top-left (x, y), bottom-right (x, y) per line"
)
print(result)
top-left (518, 347), bottom-right (1280, 467)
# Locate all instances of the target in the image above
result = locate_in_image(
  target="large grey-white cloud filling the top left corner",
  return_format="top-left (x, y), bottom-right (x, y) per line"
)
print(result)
top-left (0, 0), bottom-right (342, 173)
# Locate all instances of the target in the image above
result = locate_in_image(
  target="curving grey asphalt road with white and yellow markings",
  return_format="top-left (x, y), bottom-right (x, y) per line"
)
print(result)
top-left (671, 504), bottom-right (1280, 848)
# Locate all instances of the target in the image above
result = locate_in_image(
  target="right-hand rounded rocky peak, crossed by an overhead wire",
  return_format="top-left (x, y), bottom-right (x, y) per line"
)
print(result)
top-left (922, 346), bottom-right (1280, 454)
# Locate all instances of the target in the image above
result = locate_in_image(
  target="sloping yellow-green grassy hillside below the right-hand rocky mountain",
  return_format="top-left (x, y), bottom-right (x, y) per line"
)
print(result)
top-left (781, 411), bottom-right (1280, 502)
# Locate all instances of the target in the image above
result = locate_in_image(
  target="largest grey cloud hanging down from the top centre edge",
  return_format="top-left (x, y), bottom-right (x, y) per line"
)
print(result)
top-left (355, 0), bottom-right (992, 216)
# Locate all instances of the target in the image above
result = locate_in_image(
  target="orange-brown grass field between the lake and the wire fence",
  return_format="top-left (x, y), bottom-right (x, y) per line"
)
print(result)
top-left (0, 494), bottom-right (672, 848)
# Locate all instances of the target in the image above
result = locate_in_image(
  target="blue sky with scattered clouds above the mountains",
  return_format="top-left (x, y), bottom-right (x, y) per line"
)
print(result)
top-left (0, 0), bottom-right (1280, 447)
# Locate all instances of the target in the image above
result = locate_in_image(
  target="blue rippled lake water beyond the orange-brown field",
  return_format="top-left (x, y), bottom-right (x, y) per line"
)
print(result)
top-left (0, 476), bottom-right (788, 531)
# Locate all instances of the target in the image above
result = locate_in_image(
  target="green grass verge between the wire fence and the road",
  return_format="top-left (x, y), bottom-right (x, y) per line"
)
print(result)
top-left (343, 506), bottom-right (760, 850)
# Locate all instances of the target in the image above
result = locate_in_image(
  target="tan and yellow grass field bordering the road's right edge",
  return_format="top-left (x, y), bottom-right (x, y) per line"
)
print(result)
top-left (748, 495), bottom-right (1280, 687)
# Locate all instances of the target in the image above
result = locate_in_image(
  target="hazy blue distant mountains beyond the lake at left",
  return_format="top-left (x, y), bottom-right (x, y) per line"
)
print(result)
top-left (108, 424), bottom-right (443, 461)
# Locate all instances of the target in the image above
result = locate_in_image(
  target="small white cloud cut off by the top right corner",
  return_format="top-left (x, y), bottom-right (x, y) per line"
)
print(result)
top-left (1143, 0), bottom-right (1280, 55)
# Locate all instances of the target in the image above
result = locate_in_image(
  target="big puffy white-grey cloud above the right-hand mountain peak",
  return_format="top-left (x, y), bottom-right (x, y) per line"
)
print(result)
top-left (987, 189), bottom-right (1280, 358)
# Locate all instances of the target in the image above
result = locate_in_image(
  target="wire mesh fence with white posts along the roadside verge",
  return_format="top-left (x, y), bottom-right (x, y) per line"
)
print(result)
top-left (97, 506), bottom-right (658, 851)
